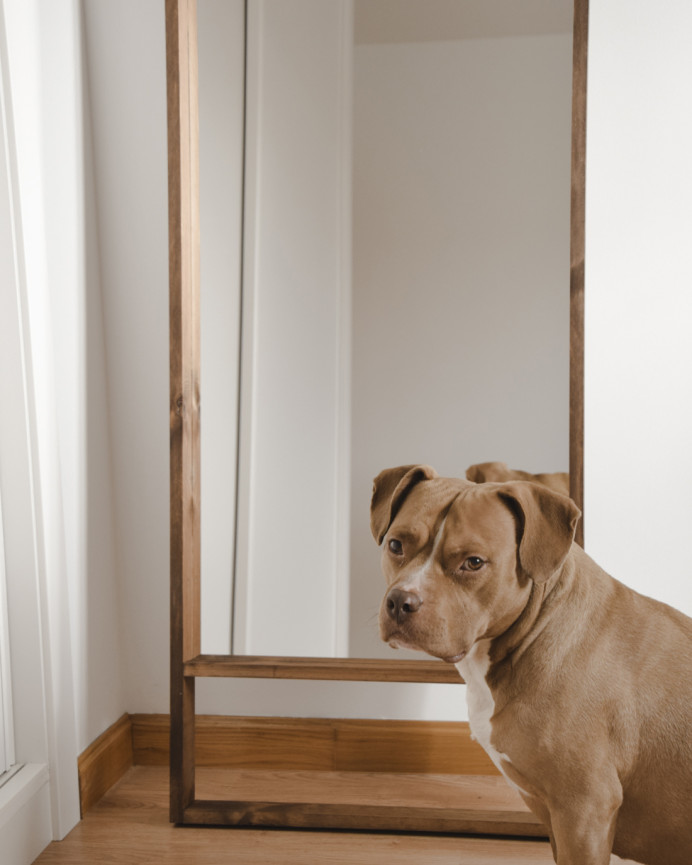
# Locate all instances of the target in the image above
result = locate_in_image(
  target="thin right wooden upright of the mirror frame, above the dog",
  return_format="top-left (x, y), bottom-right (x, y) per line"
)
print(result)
top-left (569, 0), bottom-right (589, 546)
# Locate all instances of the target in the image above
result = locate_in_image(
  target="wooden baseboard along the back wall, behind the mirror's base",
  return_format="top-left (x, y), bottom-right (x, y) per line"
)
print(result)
top-left (131, 715), bottom-right (498, 780)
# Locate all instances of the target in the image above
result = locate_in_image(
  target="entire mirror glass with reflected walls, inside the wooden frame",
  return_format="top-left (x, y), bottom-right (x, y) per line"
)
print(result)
top-left (198, 0), bottom-right (572, 658)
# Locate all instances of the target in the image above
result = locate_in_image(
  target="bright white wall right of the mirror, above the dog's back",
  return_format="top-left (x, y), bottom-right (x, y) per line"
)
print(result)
top-left (584, 0), bottom-right (692, 614)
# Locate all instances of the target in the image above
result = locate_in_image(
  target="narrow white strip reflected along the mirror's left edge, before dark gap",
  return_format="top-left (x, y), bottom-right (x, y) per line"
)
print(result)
top-left (197, 0), bottom-right (245, 654)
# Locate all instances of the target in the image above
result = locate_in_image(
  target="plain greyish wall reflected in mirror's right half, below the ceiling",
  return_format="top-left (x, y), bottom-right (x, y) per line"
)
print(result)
top-left (350, 34), bottom-right (572, 657)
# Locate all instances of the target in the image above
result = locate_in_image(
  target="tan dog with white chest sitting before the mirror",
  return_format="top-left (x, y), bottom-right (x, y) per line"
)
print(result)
top-left (371, 466), bottom-right (692, 865)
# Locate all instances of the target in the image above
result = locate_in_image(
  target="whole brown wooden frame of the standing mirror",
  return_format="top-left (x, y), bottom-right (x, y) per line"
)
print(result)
top-left (166, 0), bottom-right (588, 834)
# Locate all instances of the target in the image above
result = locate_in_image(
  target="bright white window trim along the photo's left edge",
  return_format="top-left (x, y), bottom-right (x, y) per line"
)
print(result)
top-left (0, 0), bottom-right (79, 852)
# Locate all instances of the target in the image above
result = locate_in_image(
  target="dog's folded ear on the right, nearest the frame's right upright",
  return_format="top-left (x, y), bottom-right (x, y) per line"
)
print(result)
top-left (497, 481), bottom-right (581, 583)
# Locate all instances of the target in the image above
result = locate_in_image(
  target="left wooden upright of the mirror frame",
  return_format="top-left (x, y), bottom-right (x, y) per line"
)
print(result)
top-left (165, 0), bottom-right (200, 819)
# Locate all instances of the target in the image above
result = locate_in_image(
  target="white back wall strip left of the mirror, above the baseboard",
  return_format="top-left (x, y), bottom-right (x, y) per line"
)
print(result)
top-left (83, 0), bottom-right (169, 723)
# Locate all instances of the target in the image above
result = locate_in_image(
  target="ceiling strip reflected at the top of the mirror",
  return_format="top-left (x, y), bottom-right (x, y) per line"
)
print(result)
top-left (355, 0), bottom-right (573, 44)
